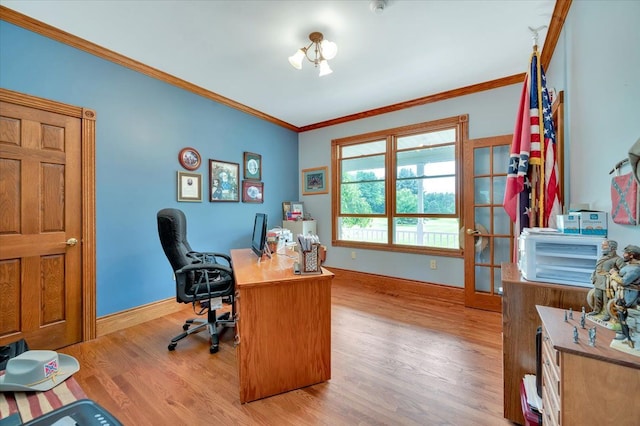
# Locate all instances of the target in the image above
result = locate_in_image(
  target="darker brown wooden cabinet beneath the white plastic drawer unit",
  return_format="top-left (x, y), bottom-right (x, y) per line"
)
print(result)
top-left (501, 263), bottom-right (589, 424)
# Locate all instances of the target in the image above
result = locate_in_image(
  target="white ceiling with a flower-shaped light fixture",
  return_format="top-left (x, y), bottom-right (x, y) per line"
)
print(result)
top-left (0, 0), bottom-right (555, 127)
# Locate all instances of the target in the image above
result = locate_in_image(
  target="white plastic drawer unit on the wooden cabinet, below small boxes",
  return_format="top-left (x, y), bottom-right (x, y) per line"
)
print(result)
top-left (518, 232), bottom-right (605, 287)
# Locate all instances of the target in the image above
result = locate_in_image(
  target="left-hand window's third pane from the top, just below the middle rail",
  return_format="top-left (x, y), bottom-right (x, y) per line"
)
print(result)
top-left (340, 182), bottom-right (385, 214)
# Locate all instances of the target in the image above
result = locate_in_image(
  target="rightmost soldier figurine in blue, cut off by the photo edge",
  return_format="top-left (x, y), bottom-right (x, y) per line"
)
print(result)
top-left (611, 245), bottom-right (640, 348)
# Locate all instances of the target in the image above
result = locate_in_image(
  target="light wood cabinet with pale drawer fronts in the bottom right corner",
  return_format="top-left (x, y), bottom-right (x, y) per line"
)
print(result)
top-left (537, 306), bottom-right (640, 426)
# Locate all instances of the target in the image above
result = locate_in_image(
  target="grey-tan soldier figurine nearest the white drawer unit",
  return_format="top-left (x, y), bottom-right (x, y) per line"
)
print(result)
top-left (587, 240), bottom-right (624, 321)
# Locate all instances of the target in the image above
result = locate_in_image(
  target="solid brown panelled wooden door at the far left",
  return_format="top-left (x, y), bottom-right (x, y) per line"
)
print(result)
top-left (0, 90), bottom-right (95, 349)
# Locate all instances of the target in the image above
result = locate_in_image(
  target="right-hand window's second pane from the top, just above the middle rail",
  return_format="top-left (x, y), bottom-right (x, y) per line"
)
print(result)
top-left (396, 145), bottom-right (456, 178)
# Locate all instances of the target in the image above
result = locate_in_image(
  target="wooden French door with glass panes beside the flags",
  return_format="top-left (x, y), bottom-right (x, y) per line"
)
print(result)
top-left (462, 135), bottom-right (513, 312)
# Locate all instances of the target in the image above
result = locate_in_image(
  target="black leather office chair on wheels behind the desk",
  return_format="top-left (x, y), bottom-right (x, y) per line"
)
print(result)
top-left (157, 209), bottom-right (236, 354)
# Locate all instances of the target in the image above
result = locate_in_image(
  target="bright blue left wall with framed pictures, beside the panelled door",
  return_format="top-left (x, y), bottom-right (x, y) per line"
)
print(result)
top-left (0, 21), bottom-right (299, 316)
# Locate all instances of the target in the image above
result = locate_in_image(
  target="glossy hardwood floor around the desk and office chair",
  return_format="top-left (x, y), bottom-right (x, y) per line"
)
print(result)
top-left (60, 280), bottom-right (511, 426)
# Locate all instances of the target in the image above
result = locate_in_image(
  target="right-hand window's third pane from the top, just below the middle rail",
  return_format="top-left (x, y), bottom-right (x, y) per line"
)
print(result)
top-left (396, 177), bottom-right (456, 214)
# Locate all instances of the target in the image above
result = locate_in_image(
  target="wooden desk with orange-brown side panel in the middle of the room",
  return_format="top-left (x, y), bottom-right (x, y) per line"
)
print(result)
top-left (231, 249), bottom-right (333, 403)
